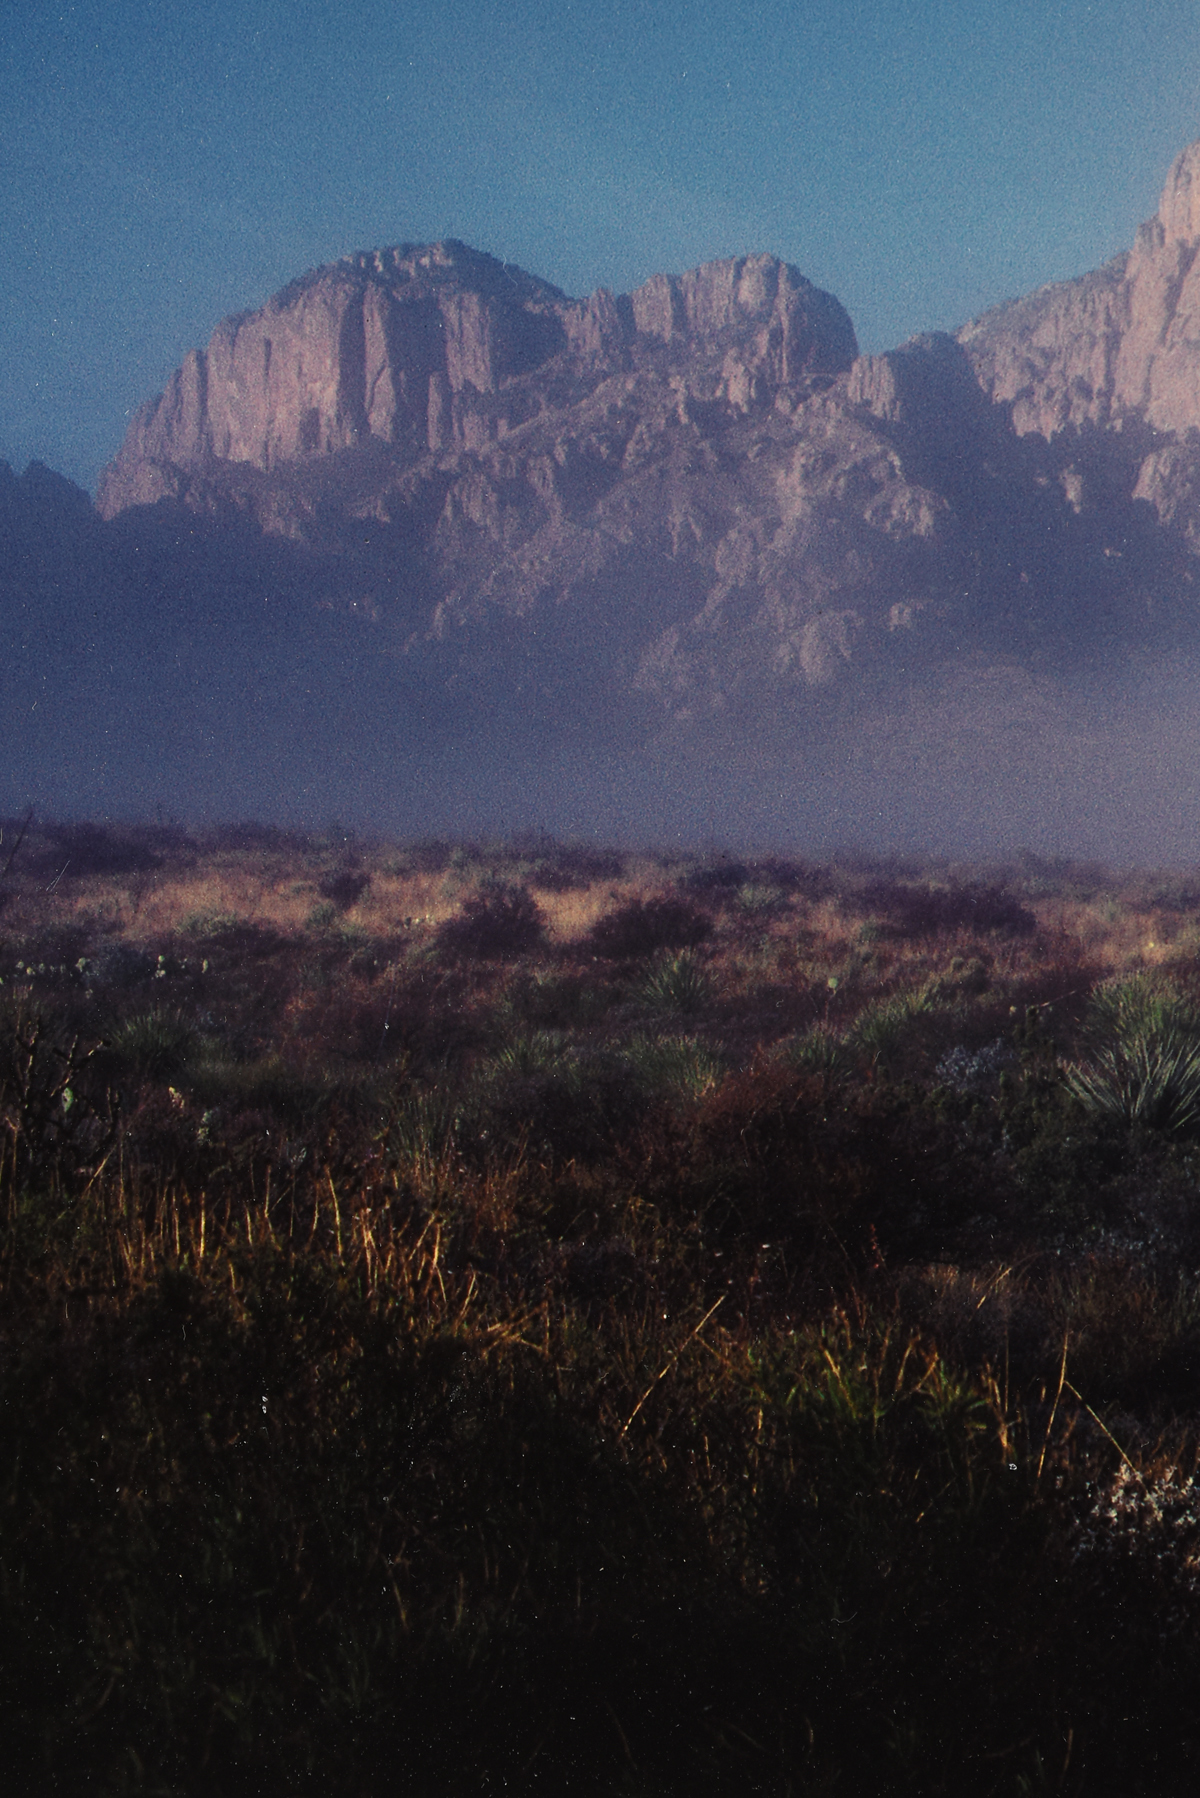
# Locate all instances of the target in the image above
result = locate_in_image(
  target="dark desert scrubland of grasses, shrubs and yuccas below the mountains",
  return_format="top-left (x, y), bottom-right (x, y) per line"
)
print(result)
top-left (0, 822), bottom-right (1200, 1798)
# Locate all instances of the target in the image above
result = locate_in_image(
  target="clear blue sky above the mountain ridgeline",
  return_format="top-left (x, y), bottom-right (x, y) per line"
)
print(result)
top-left (0, 0), bottom-right (1200, 487)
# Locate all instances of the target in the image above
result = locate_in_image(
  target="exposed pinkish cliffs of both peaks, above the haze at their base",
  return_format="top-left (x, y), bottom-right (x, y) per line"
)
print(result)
top-left (84, 146), bottom-right (1200, 732)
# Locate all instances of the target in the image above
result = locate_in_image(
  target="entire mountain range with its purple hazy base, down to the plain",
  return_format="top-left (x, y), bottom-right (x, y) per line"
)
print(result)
top-left (11, 134), bottom-right (1200, 859)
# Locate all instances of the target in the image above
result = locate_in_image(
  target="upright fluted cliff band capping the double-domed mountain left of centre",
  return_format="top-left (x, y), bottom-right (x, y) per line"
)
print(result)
top-left (99, 243), bottom-right (856, 518)
